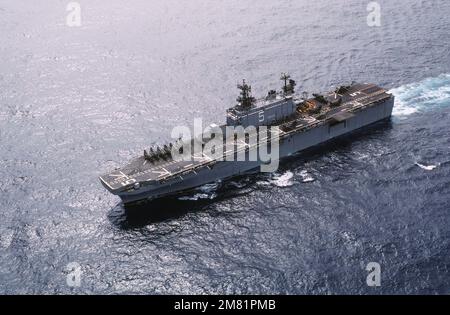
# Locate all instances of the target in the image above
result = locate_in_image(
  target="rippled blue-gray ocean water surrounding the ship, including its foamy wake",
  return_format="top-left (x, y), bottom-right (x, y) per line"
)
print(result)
top-left (0, 0), bottom-right (450, 294)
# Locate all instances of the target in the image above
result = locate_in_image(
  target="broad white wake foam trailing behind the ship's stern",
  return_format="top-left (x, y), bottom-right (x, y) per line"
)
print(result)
top-left (389, 74), bottom-right (450, 118)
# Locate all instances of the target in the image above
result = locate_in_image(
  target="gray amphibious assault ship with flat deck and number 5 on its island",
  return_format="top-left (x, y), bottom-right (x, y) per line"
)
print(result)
top-left (100, 74), bottom-right (394, 204)
